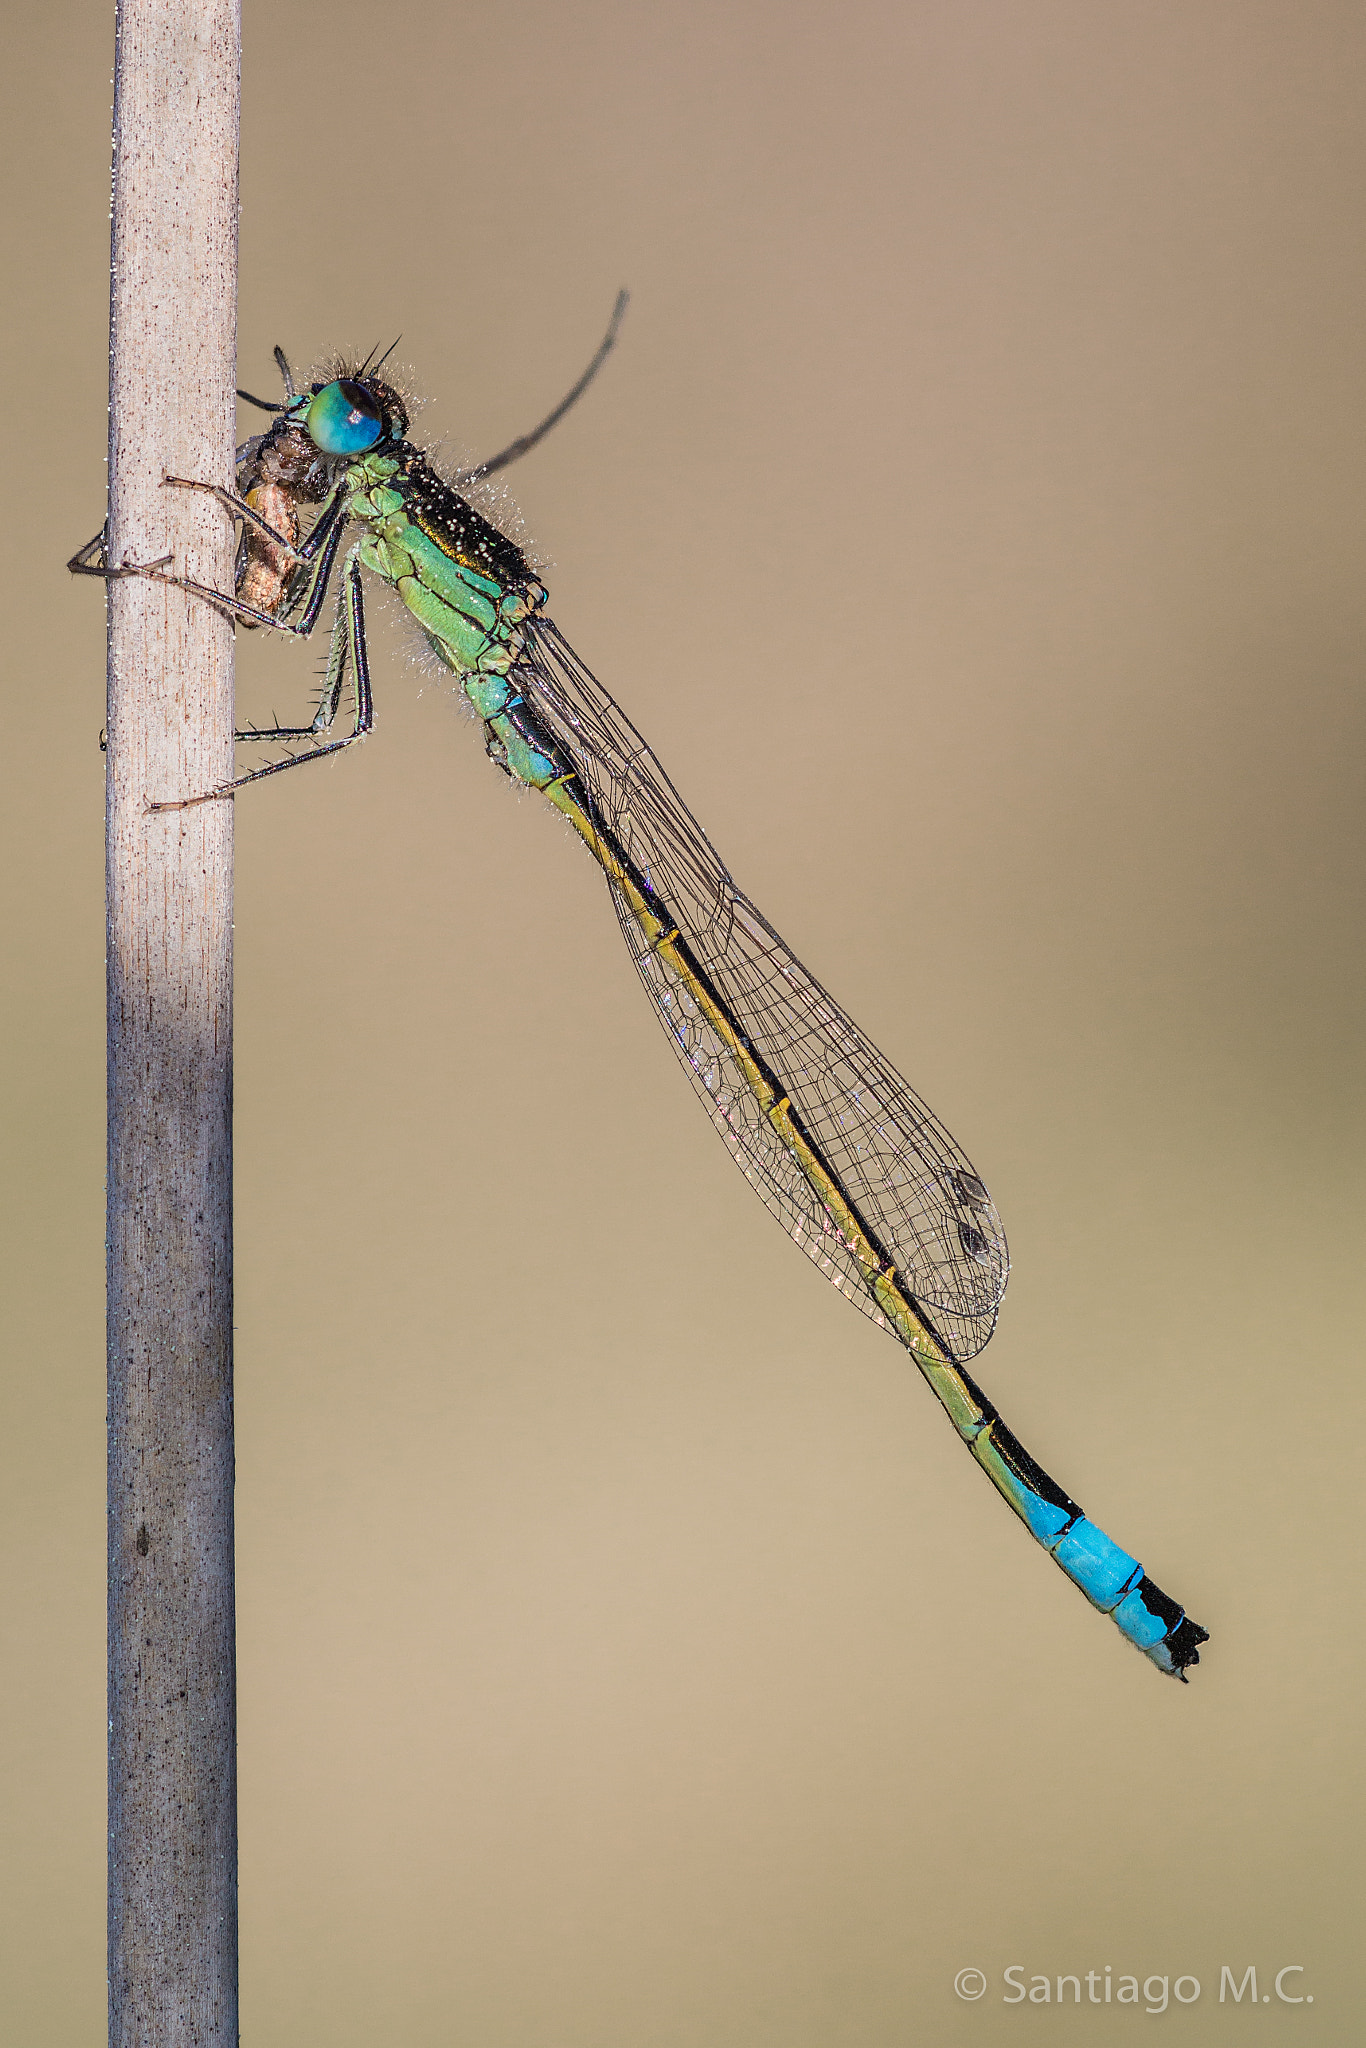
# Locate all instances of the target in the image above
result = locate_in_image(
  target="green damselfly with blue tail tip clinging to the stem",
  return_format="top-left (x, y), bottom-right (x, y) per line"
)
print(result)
top-left (72, 301), bottom-right (1208, 1681)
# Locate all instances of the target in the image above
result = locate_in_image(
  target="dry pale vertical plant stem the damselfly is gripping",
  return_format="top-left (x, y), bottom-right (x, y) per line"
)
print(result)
top-left (106, 0), bottom-right (240, 2048)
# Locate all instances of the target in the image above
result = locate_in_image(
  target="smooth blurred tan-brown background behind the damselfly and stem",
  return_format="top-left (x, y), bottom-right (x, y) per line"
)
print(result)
top-left (0, 0), bottom-right (1366, 2048)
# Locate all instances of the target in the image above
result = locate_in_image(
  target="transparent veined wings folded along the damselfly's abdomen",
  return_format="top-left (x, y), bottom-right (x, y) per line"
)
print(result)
top-left (516, 618), bottom-right (1010, 1360)
